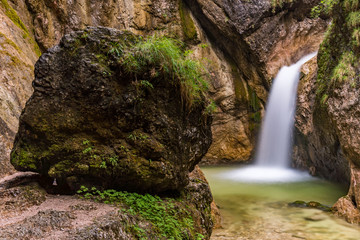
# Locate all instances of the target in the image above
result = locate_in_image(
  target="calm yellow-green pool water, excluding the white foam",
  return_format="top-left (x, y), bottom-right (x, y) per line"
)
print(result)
top-left (201, 167), bottom-right (360, 240)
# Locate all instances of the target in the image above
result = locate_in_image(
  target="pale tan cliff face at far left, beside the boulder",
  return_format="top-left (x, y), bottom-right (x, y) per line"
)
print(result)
top-left (0, 0), bottom-right (40, 176)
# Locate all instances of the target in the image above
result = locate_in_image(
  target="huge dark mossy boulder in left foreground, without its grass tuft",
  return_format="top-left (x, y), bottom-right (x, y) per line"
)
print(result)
top-left (11, 28), bottom-right (211, 192)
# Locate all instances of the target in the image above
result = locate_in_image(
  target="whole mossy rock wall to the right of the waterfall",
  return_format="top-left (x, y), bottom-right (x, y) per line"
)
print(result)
top-left (297, 1), bottom-right (360, 223)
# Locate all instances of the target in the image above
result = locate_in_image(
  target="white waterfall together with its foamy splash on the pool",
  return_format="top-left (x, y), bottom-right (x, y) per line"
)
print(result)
top-left (226, 53), bottom-right (316, 182)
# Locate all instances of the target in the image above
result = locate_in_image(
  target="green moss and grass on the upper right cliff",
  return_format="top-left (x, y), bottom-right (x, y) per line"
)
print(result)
top-left (313, 0), bottom-right (360, 104)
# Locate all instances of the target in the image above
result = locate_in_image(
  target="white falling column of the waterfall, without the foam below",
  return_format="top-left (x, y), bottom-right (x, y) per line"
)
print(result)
top-left (255, 53), bottom-right (316, 168)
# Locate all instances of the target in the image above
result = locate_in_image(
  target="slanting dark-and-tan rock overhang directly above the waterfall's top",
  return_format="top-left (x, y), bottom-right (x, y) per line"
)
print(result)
top-left (186, 0), bottom-right (327, 102)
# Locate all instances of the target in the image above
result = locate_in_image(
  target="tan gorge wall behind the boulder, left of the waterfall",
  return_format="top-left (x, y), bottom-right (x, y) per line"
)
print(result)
top-left (0, 0), bottom-right (327, 178)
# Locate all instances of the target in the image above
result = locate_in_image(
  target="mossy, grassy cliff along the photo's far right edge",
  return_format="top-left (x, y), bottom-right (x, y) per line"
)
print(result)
top-left (314, 0), bottom-right (360, 223)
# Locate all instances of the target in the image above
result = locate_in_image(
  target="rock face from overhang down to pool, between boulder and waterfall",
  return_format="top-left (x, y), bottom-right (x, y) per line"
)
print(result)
top-left (185, 0), bottom-right (327, 163)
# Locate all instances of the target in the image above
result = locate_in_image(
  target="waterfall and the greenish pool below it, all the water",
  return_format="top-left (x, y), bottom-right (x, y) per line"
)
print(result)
top-left (202, 53), bottom-right (360, 240)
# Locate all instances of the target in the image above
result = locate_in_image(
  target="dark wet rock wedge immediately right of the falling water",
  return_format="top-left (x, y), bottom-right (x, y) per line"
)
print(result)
top-left (293, 57), bottom-right (350, 183)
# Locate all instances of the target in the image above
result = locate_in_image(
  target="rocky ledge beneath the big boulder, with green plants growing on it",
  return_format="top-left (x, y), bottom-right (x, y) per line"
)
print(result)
top-left (0, 168), bottom-right (213, 240)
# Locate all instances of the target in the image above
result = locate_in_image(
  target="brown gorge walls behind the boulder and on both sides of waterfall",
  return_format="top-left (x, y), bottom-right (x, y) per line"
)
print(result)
top-left (0, 0), bottom-right (360, 232)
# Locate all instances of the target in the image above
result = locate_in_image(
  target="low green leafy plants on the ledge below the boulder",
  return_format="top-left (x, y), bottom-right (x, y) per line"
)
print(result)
top-left (77, 186), bottom-right (204, 239)
